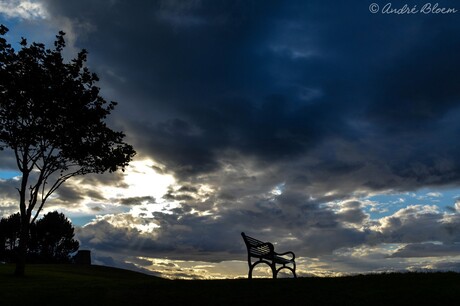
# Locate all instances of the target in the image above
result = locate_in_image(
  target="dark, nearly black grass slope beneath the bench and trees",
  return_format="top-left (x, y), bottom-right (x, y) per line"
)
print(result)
top-left (0, 265), bottom-right (460, 306)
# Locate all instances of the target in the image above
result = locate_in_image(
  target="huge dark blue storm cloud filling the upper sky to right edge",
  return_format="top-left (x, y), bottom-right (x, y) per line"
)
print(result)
top-left (36, 1), bottom-right (460, 194)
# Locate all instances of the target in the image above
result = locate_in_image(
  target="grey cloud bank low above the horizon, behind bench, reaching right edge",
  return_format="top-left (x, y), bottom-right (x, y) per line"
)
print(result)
top-left (71, 176), bottom-right (459, 277)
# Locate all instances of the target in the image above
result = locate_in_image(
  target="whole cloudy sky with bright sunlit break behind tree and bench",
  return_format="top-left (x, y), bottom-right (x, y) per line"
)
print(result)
top-left (0, 0), bottom-right (460, 279)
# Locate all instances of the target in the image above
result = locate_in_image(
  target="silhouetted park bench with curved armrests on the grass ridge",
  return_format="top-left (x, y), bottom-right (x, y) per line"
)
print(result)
top-left (241, 233), bottom-right (297, 279)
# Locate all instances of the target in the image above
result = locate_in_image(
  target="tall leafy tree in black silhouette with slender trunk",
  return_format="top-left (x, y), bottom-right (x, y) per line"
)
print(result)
top-left (0, 25), bottom-right (135, 276)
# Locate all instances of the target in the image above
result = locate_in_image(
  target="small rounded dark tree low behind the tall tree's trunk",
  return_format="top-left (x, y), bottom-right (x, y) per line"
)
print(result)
top-left (29, 211), bottom-right (80, 263)
